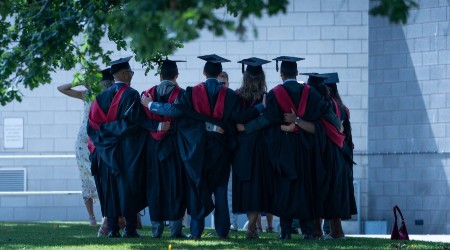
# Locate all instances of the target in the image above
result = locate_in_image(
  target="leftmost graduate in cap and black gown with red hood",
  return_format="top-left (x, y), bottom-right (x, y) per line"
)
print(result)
top-left (87, 57), bottom-right (148, 238)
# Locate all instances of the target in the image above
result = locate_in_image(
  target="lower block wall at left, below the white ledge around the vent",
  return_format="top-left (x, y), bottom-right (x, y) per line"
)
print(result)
top-left (0, 155), bottom-right (101, 222)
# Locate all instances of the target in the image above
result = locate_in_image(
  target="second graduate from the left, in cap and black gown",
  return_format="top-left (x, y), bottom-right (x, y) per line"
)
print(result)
top-left (143, 58), bottom-right (186, 238)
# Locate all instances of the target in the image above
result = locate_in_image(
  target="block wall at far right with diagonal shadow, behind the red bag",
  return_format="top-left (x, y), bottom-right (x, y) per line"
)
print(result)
top-left (367, 0), bottom-right (450, 234)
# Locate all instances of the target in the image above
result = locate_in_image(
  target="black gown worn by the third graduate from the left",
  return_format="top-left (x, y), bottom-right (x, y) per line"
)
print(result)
top-left (176, 79), bottom-right (259, 220)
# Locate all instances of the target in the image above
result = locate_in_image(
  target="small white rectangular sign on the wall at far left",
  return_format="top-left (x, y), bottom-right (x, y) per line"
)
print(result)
top-left (3, 118), bottom-right (23, 149)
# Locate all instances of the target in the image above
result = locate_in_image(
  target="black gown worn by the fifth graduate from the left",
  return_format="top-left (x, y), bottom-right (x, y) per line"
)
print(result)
top-left (246, 81), bottom-right (336, 219)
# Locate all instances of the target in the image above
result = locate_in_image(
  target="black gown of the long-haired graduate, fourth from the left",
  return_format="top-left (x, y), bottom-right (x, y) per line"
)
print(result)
top-left (232, 94), bottom-right (273, 213)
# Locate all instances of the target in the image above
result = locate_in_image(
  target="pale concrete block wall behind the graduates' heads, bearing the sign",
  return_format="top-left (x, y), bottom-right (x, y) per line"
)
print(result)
top-left (0, 0), bottom-right (369, 225)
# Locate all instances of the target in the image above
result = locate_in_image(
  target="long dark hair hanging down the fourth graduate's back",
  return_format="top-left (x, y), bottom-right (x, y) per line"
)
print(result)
top-left (239, 71), bottom-right (267, 101)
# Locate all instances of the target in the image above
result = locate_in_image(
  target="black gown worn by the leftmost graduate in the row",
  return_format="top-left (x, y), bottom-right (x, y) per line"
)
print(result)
top-left (87, 83), bottom-right (148, 217)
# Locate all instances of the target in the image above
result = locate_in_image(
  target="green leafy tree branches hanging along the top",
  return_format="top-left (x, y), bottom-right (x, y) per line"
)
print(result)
top-left (0, 0), bottom-right (411, 105)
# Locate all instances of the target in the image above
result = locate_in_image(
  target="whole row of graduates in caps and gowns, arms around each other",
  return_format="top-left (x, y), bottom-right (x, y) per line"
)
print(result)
top-left (87, 54), bottom-right (357, 239)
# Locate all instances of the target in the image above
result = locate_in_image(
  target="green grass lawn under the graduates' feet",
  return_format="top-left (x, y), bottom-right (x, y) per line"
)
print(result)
top-left (0, 222), bottom-right (450, 250)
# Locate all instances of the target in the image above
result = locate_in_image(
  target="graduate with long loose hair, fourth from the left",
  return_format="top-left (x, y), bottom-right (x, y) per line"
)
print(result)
top-left (232, 57), bottom-right (273, 239)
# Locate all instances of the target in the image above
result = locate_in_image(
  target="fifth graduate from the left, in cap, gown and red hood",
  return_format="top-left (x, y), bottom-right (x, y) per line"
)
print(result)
top-left (244, 56), bottom-right (340, 239)
